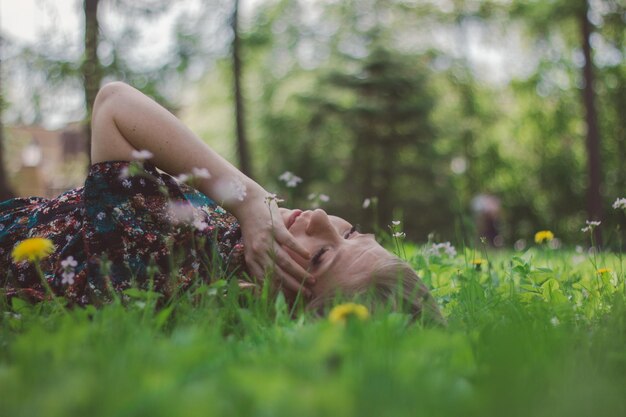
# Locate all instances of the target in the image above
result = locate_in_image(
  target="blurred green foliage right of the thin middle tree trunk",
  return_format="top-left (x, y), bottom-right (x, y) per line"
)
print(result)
top-left (222, 0), bottom-right (626, 248)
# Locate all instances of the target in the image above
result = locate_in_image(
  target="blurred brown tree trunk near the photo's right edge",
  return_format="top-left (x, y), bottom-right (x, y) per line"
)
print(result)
top-left (579, 0), bottom-right (602, 245)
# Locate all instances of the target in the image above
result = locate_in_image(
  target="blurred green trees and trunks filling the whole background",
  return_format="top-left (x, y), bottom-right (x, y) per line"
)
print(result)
top-left (2, 0), bottom-right (626, 248)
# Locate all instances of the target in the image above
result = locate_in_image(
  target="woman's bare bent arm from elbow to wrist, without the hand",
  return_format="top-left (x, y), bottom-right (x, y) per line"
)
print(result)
top-left (92, 83), bottom-right (267, 213)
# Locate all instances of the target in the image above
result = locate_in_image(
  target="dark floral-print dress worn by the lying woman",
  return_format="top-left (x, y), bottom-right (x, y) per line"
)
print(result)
top-left (0, 161), bottom-right (245, 305)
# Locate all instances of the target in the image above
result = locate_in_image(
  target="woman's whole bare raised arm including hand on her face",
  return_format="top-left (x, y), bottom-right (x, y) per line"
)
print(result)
top-left (91, 82), bottom-right (313, 294)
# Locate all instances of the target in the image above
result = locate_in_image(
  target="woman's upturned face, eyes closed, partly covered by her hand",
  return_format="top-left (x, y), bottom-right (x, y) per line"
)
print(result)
top-left (280, 209), bottom-right (390, 295)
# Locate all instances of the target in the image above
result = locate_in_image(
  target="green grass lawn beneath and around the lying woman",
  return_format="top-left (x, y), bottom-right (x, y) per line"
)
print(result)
top-left (0, 246), bottom-right (626, 417)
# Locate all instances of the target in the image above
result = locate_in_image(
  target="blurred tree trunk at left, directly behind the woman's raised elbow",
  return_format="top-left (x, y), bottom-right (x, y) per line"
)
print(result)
top-left (81, 0), bottom-right (102, 166)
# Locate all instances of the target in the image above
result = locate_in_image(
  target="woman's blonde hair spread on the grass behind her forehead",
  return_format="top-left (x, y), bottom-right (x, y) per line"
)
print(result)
top-left (308, 255), bottom-right (446, 326)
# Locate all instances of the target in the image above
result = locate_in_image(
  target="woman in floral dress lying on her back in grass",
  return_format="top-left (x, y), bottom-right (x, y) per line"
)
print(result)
top-left (0, 83), bottom-right (441, 321)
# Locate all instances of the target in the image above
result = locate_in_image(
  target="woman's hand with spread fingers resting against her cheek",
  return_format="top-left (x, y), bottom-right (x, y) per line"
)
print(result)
top-left (236, 196), bottom-right (315, 296)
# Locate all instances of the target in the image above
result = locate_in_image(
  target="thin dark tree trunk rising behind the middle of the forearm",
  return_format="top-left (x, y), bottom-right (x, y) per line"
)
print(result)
top-left (231, 0), bottom-right (252, 177)
